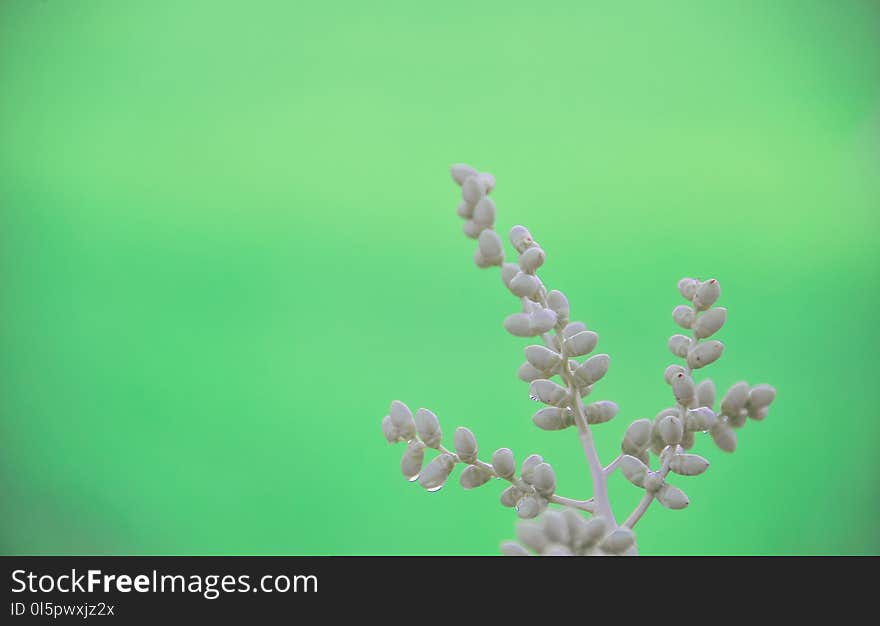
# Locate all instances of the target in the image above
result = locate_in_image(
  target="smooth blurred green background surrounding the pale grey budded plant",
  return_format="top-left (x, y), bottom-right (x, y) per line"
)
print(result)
top-left (0, 0), bottom-right (880, 554)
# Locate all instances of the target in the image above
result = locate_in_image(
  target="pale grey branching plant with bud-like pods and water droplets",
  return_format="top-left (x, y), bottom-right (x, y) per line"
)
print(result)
top-left (382, 164), bottom-right (776, 556)
